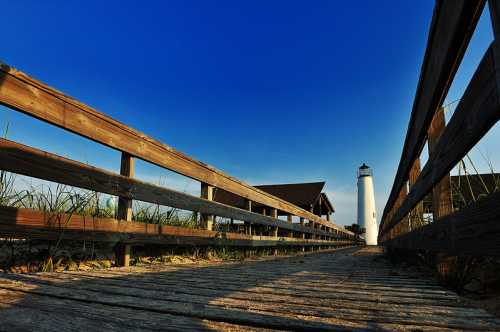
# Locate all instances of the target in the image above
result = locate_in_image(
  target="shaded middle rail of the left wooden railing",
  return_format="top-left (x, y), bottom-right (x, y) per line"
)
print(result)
top-left (0, 139), bottom-right (344, 239)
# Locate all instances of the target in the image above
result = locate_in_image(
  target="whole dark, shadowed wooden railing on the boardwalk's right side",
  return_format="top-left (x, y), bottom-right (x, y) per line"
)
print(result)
top-left (379, 0), bottom-right (500, 255)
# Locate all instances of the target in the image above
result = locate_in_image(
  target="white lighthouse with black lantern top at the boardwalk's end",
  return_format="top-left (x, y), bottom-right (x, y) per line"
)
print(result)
top-left (358, 164), bottom-right (378, 246)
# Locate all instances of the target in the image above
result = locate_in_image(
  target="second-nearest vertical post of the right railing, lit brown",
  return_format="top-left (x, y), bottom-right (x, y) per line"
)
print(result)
top-left (427, 107), bottom-right (453, 221)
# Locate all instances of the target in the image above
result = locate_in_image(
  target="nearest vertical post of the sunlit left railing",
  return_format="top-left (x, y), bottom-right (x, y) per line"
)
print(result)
top-left (115, 152), bottom-right (135, 266)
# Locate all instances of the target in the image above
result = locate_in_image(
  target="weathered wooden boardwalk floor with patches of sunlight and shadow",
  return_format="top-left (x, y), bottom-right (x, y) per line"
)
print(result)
top-left (0, 248), bottom-right (500, 331)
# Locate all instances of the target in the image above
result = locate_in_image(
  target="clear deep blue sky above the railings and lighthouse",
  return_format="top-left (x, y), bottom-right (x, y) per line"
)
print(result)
top-left (0, 1), bottom-right (497, 224)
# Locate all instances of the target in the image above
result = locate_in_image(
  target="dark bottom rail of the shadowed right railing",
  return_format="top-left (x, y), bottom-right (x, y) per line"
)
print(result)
top-left (384, 192), bottom-right (500, 256)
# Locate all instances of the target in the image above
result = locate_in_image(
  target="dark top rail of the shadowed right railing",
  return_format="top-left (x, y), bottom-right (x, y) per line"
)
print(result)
top-left (381, 0), bottom-right (485, 229)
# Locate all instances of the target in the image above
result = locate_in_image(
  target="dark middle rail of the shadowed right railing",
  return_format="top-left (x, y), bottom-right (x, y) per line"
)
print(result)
top-left (381, 44), bottom-right (500, 239)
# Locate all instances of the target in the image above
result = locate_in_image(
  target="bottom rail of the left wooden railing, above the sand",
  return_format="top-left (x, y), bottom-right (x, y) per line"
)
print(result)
top-left (0, 207), bottom-right (354, 247)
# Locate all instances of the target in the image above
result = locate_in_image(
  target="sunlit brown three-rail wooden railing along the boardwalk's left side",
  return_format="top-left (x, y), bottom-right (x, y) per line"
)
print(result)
top-left (0, 57), bottom-right (358, 266)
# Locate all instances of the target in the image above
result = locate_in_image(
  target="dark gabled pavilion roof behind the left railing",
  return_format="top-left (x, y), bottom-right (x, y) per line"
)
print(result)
top-left (214, 182), bottom-right (333, 211)
